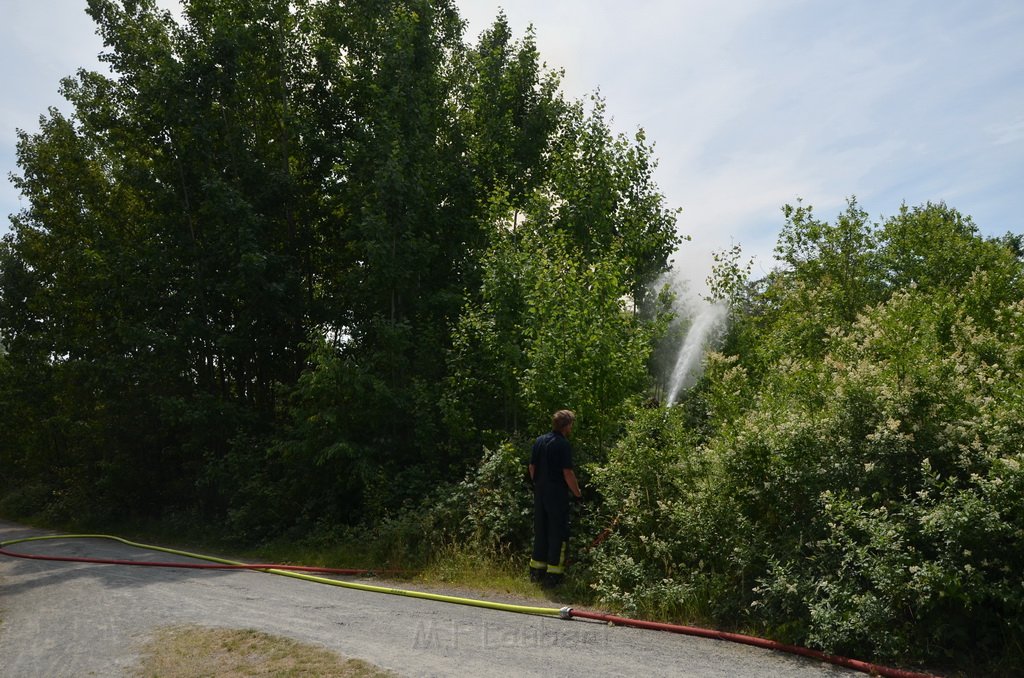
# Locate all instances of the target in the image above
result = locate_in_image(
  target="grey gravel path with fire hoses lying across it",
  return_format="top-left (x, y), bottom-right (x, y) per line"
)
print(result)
top-left (0, 522), bottom-right (864, 678)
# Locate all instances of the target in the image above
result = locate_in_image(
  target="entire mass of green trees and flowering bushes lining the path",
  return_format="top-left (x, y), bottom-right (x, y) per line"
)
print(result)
top-left (0, 0), bottom-right (1024, 670)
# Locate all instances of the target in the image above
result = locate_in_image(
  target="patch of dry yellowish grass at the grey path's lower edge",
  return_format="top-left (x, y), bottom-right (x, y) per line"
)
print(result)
top-left (135, 626), bottom-right (395, 678)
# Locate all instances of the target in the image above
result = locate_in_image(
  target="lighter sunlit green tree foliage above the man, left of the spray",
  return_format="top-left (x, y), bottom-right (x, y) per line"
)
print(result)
top-left (447, 227), bottom-right (657, 460)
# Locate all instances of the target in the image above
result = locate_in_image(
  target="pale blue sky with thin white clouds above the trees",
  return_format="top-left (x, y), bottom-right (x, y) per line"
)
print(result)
top-left (0, 0), bottom-right (1024, 284)
